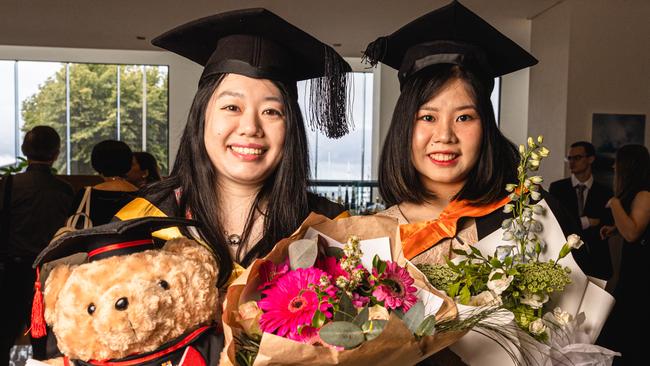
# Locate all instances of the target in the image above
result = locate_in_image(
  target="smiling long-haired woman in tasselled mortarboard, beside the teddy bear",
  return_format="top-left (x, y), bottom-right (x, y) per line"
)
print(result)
top-left (117, 9), bottom-right (350, 286)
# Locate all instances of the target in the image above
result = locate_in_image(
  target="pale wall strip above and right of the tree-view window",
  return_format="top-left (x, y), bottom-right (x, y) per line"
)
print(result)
top-left (0, 45), bottom-right (202, 167)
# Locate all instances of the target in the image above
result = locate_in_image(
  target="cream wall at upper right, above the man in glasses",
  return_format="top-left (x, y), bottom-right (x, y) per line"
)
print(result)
top-left (528, 0), bottom-right (650, 183)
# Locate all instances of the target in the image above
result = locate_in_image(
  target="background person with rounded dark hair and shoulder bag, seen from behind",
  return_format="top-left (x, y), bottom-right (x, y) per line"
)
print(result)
top-left (71, 140), bottom-right (138, 226)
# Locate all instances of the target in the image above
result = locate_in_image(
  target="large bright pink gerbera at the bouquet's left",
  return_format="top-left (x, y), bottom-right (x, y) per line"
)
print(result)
top-left (258, 268), bottom-right (332, 342)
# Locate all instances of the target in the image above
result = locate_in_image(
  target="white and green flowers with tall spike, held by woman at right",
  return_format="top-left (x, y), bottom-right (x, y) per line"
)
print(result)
top-left (418, 136), bottom-right (614, 364)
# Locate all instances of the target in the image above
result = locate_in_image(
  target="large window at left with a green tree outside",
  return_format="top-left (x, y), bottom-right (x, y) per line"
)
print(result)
top-left (0, 61), bottom-right (169, 174)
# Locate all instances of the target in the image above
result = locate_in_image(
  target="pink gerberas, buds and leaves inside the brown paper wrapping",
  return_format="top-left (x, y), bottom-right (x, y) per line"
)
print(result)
top-left (236, 236), bottom-right (436, 365)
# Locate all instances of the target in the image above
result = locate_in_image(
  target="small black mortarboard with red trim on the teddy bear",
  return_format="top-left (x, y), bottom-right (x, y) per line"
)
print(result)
top-left (34, 217), bottom-right (199, 267)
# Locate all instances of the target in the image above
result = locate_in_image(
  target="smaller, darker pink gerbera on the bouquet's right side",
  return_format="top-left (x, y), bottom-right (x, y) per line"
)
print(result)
top-left (372, 262), bottom-right (418, 312)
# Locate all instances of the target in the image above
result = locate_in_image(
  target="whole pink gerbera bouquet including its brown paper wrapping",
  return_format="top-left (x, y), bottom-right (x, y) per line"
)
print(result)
top-left (221, 214), bottom-right (475, 365)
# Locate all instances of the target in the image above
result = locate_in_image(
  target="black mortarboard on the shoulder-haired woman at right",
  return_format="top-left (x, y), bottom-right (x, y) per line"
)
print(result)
top-left (364, 1), bottom-right (537, 85)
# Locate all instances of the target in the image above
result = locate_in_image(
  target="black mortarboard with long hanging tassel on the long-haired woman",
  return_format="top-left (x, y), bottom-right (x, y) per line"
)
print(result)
top-left (151, 8), bottom-right (351, 138)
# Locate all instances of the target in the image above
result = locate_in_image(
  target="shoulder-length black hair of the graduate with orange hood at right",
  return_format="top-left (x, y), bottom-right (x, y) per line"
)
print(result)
top-left (378, 64), bottom-right (519, 205)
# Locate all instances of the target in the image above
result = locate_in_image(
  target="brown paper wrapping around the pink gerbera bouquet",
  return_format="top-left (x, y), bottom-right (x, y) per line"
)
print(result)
top-left (220, 213), bottom-right (466, 366)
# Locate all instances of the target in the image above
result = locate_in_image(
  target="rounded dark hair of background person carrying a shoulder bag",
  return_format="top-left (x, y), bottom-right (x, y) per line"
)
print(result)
top-left (90, 140), bottom-right (133, 177)
